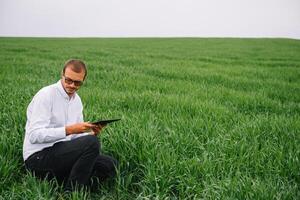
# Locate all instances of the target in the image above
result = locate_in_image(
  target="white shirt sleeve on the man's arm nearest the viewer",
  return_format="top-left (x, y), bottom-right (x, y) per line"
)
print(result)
top-left (27, 92), bottom-right (66, 144)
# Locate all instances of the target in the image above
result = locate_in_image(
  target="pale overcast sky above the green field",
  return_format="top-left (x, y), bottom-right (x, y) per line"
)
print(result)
top-left (0, 0), bottom-right (300, 39)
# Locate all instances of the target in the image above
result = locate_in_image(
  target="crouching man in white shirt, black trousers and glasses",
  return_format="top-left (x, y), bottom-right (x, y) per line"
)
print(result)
top-left (23, 60), bottom-right (117, 191)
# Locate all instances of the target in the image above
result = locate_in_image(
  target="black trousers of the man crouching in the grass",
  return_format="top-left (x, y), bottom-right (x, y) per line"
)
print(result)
top-left (25, 135), bottom-right (117, 190)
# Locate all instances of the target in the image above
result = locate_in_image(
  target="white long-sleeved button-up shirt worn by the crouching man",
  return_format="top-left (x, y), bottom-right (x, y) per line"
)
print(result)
top-left (23, 80), bottom-right (89, 160)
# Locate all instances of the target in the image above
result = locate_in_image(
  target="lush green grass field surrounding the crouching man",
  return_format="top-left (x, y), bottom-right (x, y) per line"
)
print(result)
top-left (0, 38), bottom-right (300, 199)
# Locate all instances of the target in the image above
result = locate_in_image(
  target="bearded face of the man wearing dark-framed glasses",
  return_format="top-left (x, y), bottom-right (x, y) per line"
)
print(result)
top-left (62, 67), bottom-right (85, 96)
